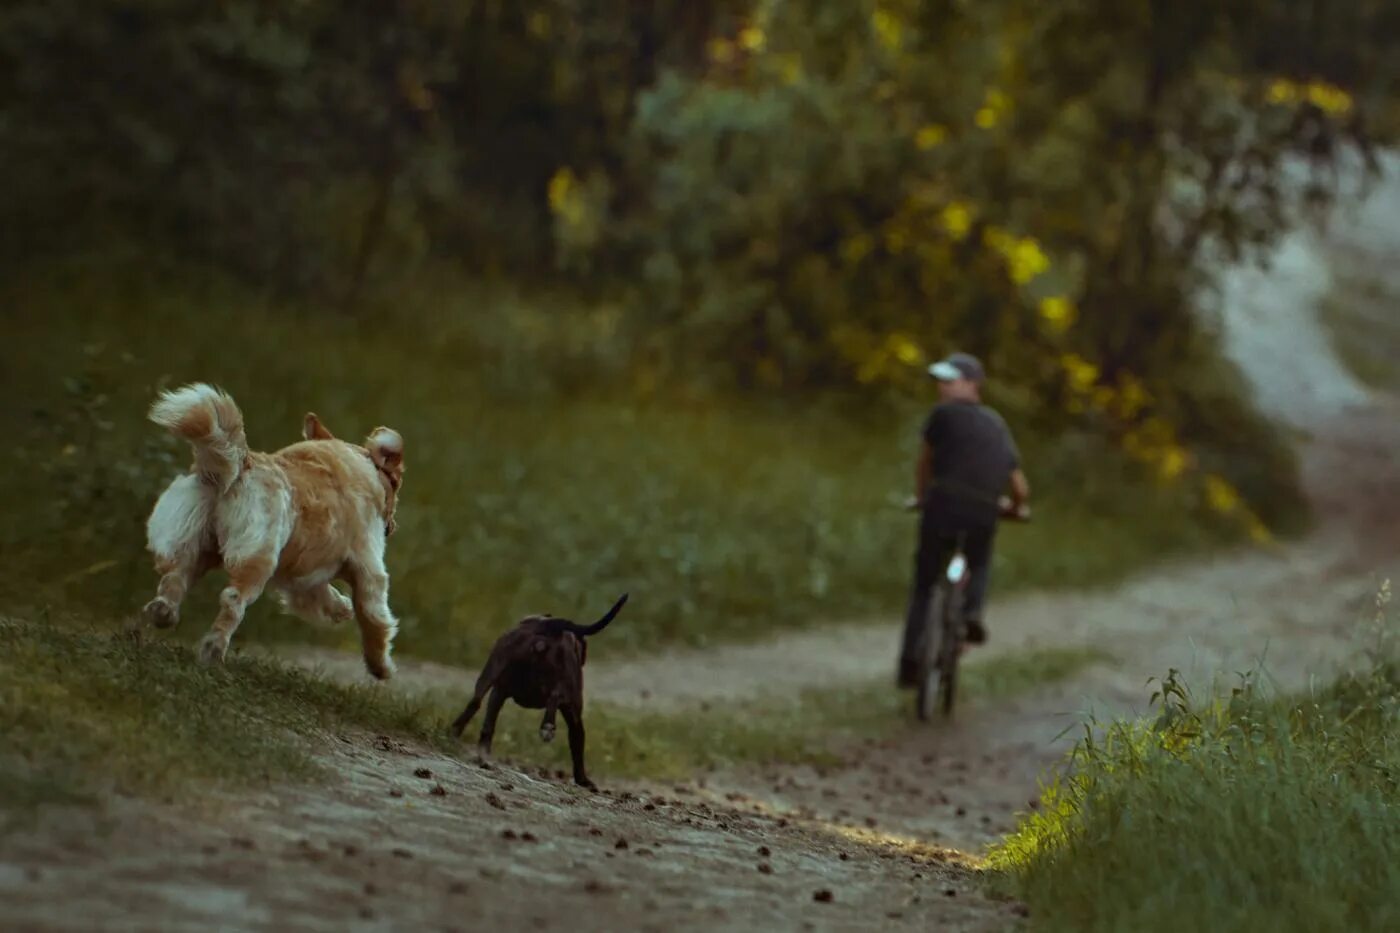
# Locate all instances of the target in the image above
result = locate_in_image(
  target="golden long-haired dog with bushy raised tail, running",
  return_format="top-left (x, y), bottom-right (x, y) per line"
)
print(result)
top-left (141, 384), bottom-right (403, 679)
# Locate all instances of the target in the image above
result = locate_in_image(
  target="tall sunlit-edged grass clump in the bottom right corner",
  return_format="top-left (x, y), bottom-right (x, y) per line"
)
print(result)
top-left (991, 591), bottom-right (1400, 933)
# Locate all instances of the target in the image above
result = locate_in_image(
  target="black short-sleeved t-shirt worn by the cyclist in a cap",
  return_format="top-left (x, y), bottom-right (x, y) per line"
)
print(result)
top-left (924, 401), bottom-right (1021, 523)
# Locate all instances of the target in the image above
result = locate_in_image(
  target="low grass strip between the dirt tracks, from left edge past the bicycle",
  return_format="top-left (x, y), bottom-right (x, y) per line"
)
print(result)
top-left (0, 619), bottom-right (1103, 815)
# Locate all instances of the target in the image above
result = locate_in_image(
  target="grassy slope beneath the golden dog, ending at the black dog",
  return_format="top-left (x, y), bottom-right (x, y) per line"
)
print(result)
top-left (0, 619), bottom-right (447, 811)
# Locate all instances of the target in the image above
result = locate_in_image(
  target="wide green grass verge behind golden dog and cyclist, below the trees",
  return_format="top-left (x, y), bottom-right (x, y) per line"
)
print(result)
top-left (0, 254), bottom-right (1232, 663)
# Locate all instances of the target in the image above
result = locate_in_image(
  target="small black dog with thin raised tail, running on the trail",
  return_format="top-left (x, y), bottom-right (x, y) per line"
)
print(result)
top-left (452, 594), bottom-right (627, 790)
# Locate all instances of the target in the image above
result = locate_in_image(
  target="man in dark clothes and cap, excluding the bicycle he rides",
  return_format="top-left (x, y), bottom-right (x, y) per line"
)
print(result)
top-left (899, 353), bottom-right (1030, 686)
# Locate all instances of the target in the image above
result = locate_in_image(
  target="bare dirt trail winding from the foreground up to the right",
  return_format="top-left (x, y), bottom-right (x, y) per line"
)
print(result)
top-left (0, 156), bottom-right (1400, 930)
